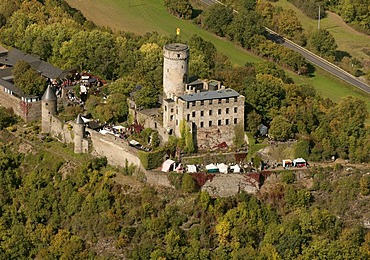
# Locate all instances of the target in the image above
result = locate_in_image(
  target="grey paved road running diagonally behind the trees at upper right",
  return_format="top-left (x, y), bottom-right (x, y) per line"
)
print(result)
top-left (200, 0), bottom-right (370, 94)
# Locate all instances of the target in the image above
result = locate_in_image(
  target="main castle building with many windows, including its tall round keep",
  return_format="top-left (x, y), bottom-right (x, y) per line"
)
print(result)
top-left (130, 43), bottom-right (245, 149)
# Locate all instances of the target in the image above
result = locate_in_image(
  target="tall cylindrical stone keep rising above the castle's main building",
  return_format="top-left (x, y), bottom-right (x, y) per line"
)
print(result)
top-left (163, 43), bottom-right (189, 99)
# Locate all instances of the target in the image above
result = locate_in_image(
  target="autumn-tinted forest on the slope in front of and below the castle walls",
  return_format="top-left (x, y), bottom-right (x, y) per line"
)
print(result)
top-left (0, 116), bottom-right (370, 259)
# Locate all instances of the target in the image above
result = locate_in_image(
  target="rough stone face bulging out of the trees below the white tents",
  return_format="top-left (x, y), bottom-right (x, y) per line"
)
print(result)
top-left (202, 174), bottom-right (259, 197)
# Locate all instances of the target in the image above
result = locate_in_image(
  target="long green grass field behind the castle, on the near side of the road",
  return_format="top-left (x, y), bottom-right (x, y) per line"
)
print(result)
top-left (67, 0), bottom-right (370, 114)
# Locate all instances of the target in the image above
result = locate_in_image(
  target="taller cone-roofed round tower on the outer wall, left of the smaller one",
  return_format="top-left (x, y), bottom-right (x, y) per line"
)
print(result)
top-left (41, 85), bottom-right (57, 133)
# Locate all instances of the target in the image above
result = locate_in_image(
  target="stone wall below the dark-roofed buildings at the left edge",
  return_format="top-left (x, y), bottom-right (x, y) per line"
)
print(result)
top-left (0, 86), bottom-right (41, 122)
